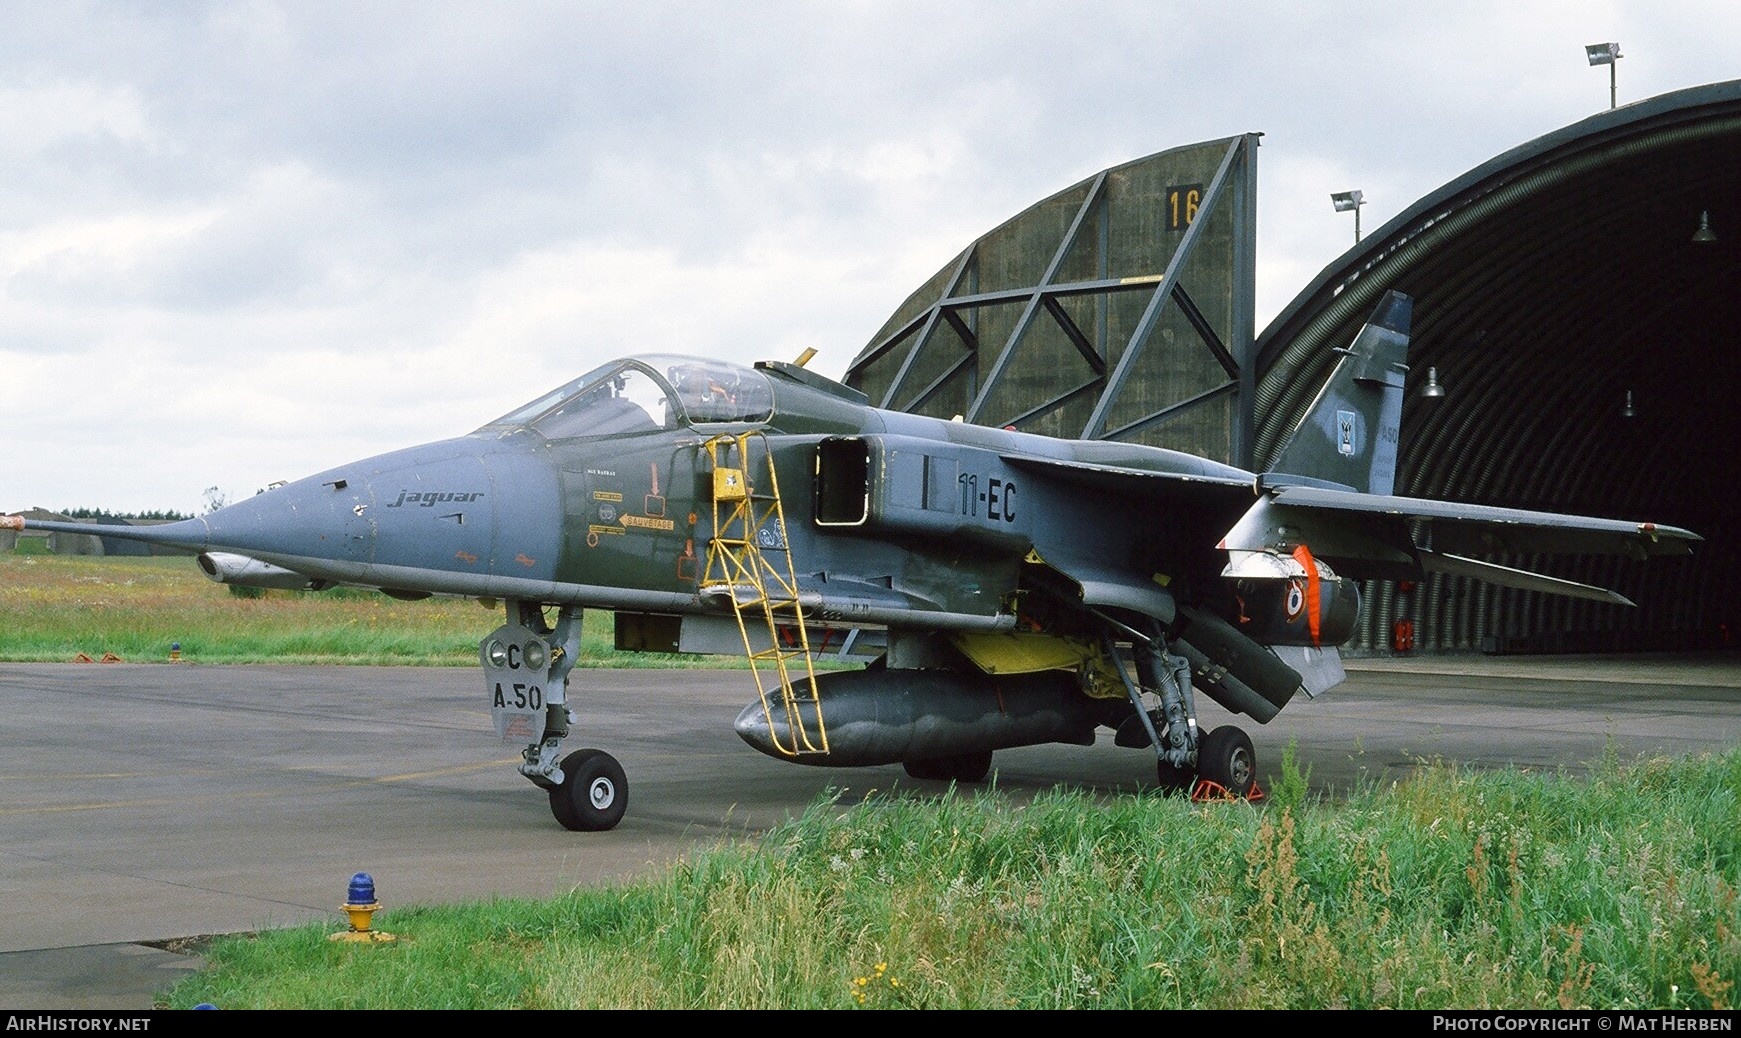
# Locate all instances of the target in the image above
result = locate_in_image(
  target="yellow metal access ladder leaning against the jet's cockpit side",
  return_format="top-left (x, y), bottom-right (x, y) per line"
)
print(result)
top-left (702, 430), bottom-right (829, 758)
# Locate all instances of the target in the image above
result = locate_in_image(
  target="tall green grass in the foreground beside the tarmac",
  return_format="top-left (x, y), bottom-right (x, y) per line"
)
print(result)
top-left (164, 752), bottom-right (1741, 1010)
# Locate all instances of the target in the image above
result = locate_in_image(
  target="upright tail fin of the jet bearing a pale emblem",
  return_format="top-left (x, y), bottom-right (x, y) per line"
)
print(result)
top-left (1264, 289), bottom-right (1414, 495)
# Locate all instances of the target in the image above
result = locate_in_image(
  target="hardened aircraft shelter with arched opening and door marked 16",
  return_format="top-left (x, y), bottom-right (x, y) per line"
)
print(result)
top-left (846, 82), bottom-right (1741, 653)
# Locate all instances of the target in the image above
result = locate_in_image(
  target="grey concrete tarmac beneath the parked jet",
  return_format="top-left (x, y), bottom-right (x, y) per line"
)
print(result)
top-left (0, 655), bottom-right (1741, 1012)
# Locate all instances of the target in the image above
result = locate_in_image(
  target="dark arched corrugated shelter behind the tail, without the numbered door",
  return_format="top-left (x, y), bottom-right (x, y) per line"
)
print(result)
top-left (1255, 80), bottom-right (1741, 650)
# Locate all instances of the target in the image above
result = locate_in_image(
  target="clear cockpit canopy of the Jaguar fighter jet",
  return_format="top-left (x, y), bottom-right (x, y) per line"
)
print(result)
top-left (484, 354), bottom-right (773, 439)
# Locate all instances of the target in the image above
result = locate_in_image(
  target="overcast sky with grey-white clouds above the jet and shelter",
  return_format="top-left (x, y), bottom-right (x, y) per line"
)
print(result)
top-left (10, 0), bottom-right (1741, 512)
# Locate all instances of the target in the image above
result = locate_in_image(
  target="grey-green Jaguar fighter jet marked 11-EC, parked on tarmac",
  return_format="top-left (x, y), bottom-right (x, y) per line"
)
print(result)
top-left (0, 293), bottom-right (1699, 831)
